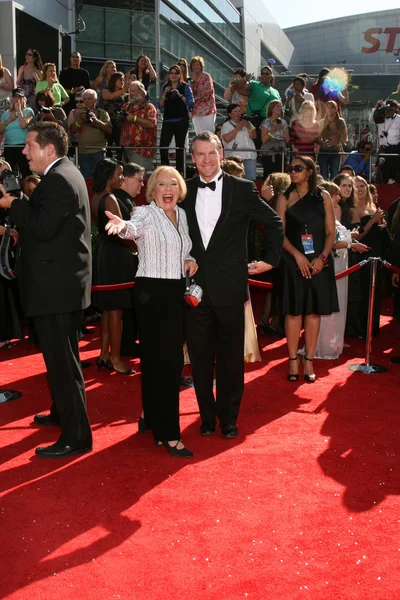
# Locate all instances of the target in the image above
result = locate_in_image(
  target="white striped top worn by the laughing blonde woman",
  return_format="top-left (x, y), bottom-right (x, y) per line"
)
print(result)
top-left (120, 202), bottom-right (194, 279)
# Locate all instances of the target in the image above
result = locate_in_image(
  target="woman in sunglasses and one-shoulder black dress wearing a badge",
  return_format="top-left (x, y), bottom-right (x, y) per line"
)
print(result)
top-left (276, 156), bottom-right (339, 383)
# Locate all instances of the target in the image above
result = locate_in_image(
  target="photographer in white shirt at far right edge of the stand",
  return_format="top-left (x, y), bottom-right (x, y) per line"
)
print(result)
top-left (368, 100), bottom-right (400, 183)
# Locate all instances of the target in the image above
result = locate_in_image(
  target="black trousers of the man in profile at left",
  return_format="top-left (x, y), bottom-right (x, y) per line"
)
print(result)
top-left (33, 311), bottom-right (92, 446)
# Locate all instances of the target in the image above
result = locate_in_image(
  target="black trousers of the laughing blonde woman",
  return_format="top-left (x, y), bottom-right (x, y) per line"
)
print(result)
top-left (134, 277), bottom-right (185, 442)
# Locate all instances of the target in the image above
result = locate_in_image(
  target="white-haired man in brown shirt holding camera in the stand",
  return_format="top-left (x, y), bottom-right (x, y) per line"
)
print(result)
top-left (69, 90), bottom-right (112, 179)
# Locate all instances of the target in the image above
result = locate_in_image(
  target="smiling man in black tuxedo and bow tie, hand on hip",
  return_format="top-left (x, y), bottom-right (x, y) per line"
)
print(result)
top-left (183, 132), bottom-right (283, 438)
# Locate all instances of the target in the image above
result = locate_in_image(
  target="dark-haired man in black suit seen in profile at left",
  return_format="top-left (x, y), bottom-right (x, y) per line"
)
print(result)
top-left (0, 122), bottom-right (92, 458)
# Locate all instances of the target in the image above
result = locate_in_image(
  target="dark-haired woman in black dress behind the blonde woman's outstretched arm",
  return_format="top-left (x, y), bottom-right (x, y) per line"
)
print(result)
top-left (92, 158), bottom-right (135, 375)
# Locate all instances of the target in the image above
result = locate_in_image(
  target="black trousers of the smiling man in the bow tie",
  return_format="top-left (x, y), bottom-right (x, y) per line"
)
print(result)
top-left (185, 299), bottom-right (244, 425)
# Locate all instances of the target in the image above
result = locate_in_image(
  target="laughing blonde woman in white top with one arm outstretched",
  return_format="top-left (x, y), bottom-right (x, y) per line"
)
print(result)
top-left (106, 166), bottom-right (197, 457)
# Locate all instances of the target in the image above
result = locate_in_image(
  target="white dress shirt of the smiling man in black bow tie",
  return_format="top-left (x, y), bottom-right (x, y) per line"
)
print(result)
top-left (196, 169), bottom-right (222, 248)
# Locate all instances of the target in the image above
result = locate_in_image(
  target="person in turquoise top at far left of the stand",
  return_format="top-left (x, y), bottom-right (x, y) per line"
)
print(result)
top-left (0, 88), bottom-right (35, 177)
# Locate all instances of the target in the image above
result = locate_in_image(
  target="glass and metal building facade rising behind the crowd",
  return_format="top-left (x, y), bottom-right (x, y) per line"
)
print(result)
top-left (76, 0), bottom-right (245, 98)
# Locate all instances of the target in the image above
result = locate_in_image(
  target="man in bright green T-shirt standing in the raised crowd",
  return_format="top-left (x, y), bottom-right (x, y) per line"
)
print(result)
top-left (235, 66), bottom-right (281, 149)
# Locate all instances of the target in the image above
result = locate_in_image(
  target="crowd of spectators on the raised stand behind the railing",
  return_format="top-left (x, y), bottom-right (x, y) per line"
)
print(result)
top-left (0, 49), bottom-right (400, 183)
